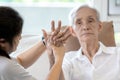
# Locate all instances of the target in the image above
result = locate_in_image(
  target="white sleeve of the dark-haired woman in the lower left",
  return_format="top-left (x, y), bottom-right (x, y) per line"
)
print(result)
top-left (0, 57), bottom-right (36, 80)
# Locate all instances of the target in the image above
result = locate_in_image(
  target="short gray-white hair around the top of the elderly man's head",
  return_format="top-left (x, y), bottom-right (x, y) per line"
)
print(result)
top-left (69, 5), bottom-right (100, 26)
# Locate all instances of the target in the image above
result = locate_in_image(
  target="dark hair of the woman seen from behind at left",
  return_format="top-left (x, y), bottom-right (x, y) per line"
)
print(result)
top-left (0, 6), bottom-right (23, 58)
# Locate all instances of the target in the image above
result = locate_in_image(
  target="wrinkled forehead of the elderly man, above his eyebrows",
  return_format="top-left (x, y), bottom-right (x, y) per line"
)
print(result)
top-left (75, 8), bottom-right (97, 19)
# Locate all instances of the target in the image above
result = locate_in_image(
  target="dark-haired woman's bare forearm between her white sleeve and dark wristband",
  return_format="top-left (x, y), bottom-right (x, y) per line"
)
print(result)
top-left (17, 41), bottom-right (46, 68)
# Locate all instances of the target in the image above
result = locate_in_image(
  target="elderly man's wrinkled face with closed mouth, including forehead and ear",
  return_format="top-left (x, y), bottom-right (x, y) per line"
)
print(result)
top-left (74, 8), bottom-right (101, 42)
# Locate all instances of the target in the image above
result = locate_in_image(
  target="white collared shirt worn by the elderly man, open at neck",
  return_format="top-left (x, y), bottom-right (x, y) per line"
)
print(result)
top-left (62, 43), bottom-right (120, 80)
